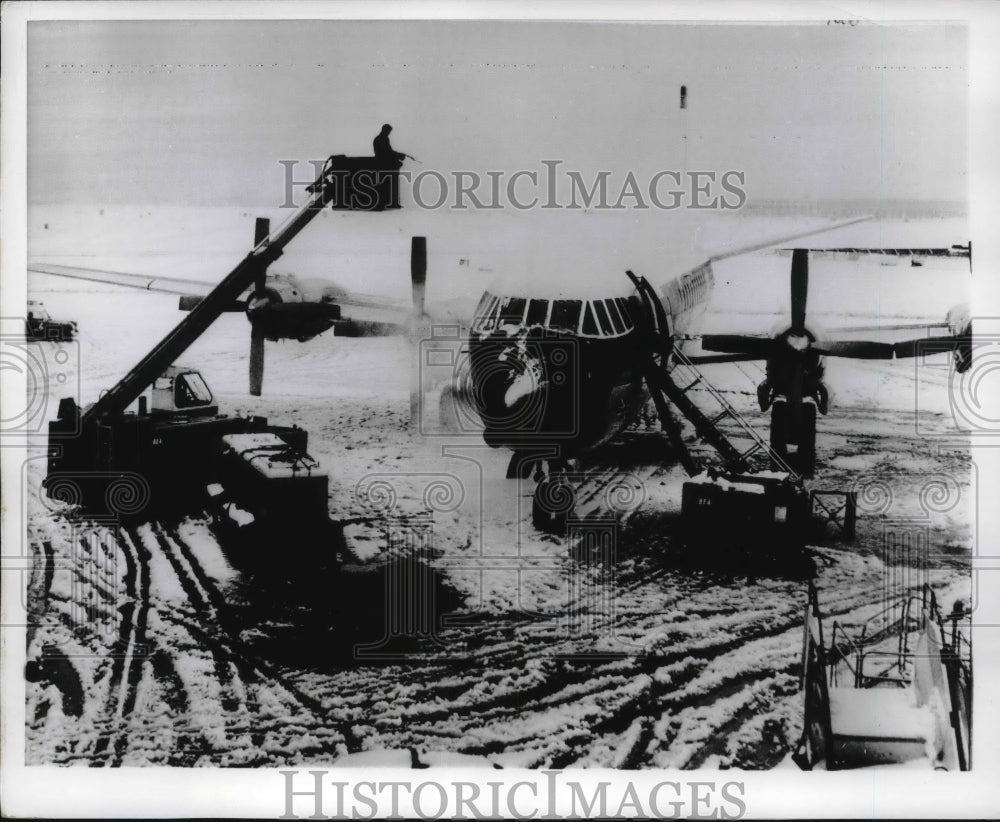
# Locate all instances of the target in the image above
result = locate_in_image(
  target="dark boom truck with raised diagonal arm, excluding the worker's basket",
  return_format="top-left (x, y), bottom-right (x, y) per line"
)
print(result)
top-left (43, 157), bottom-right (390, 525)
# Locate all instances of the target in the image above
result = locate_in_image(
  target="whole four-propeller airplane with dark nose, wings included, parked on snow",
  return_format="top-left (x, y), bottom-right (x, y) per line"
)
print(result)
top-left (29, 217), bottom-right (972, 516)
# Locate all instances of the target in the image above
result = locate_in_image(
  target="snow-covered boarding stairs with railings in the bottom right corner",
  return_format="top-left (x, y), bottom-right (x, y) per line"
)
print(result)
top-left (795, 582), bottom-right (972, 770)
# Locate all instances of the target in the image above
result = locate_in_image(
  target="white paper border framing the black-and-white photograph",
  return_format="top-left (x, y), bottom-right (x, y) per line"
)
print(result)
top-left (0, 0), bottom-right (1000, 818)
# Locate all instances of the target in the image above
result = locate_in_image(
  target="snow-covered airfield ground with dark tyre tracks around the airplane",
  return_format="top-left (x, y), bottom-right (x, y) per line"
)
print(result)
top-left (26, 207), bottom-right (975, 768)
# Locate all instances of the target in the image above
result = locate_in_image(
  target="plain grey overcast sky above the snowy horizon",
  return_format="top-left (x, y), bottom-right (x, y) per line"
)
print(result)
top-left (28, 21), bottom-right (968, 205)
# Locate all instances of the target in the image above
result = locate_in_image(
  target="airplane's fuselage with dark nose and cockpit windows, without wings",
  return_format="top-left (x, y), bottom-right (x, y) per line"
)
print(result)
top-left (465, 263), bottom-right (714, 459)
